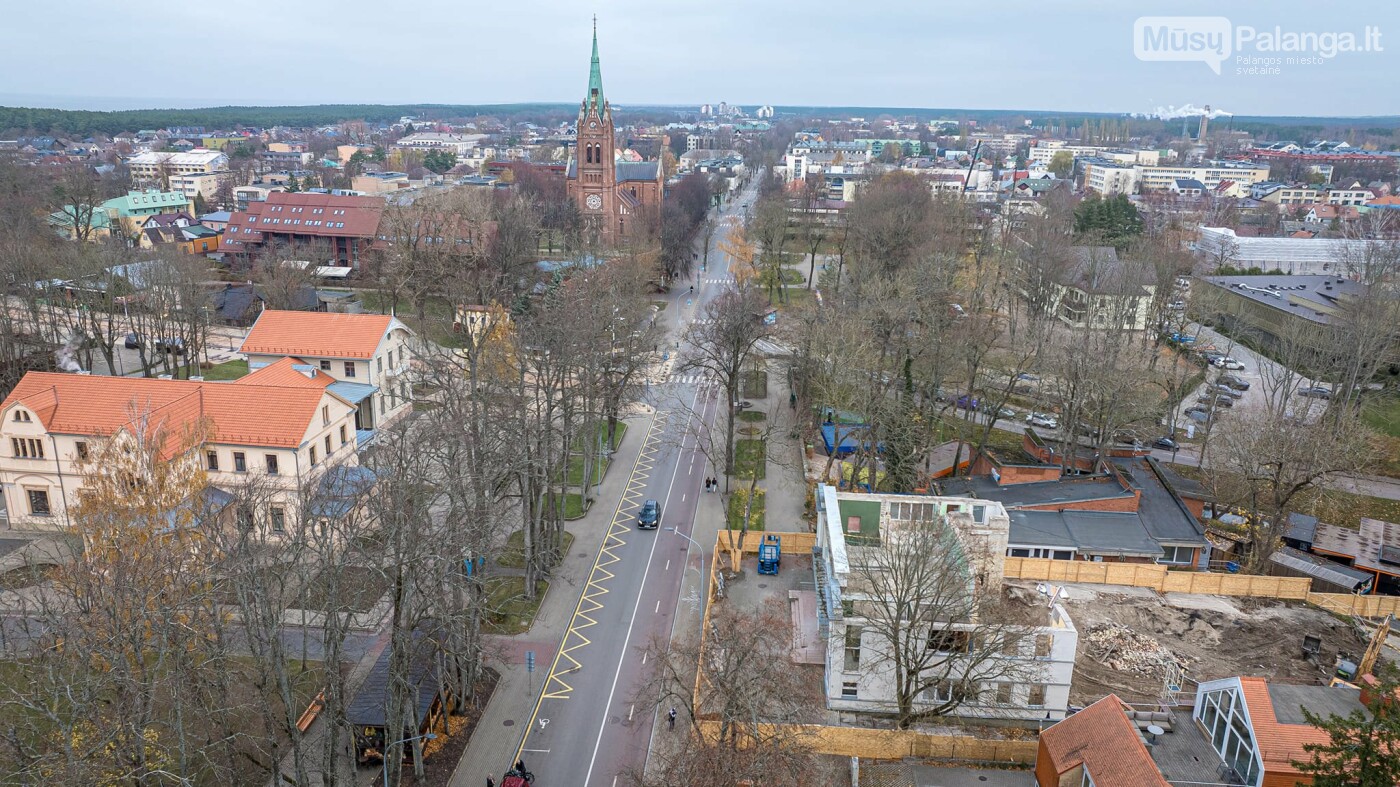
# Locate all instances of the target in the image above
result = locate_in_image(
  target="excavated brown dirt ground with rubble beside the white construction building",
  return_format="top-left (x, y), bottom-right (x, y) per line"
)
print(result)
top-left (1047, 585), bottom-right (1366, 706)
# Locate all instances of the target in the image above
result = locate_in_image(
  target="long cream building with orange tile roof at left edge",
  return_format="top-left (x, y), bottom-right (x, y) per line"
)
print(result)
top-left (0, 358), bottom-right (358, 534)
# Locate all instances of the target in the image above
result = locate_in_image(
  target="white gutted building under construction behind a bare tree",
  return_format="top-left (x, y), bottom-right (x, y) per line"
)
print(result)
top-left (813, 485), bottom-right (1078, 721)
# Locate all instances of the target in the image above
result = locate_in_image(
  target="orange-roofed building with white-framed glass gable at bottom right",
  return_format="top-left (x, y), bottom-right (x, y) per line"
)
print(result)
top-left (1191, 678), bottom-right (1365, 787)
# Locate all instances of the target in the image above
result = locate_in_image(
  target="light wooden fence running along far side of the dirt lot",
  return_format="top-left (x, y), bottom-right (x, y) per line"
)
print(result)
top-left (1005, 557), bottom-right (1400, 618)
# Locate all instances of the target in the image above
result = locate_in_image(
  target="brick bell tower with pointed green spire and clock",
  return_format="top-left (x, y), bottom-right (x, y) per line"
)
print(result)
top-left (568, 17), bottom-right (622, 242)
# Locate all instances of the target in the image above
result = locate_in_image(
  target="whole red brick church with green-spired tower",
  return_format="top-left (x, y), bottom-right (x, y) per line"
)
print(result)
top-left (568, 21), bottom-right (665, 246)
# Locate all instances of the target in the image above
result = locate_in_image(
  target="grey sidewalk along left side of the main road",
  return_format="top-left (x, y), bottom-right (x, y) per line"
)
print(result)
top-left (449, 409), bottom-right (660, 787)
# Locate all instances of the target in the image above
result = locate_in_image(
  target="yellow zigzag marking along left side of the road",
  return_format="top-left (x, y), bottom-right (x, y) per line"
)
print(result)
top-left (534, 410), bottom-right (666, 697)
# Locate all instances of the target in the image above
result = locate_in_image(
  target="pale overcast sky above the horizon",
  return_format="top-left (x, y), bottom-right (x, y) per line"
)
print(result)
top-left (0, 0), bottom-right (1400, 115)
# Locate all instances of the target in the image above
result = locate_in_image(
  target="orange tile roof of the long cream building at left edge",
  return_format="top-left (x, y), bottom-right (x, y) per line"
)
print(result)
top-left (0, 371), bottom-right (336, 448)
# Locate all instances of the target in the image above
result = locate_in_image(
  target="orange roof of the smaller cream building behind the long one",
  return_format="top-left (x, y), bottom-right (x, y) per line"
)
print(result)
top-left (242, 309), bottom-right (393, 360)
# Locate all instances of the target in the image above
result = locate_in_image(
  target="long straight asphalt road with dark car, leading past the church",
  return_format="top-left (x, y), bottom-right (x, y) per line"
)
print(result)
top-left (517, 180), bottom-right (753, 787)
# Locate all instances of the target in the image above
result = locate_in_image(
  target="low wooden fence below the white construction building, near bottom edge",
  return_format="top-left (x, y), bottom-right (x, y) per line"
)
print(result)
top-left (699, 718), bottom-right (1036, 765)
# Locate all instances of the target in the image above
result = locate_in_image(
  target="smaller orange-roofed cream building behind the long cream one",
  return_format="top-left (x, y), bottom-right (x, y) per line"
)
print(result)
top-left (242, 309), bottom-right (413, 434)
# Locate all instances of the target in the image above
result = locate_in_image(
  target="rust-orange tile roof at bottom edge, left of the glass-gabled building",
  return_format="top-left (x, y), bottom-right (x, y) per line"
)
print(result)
top-left (1040, 695), bottom-right (1169, 787)
